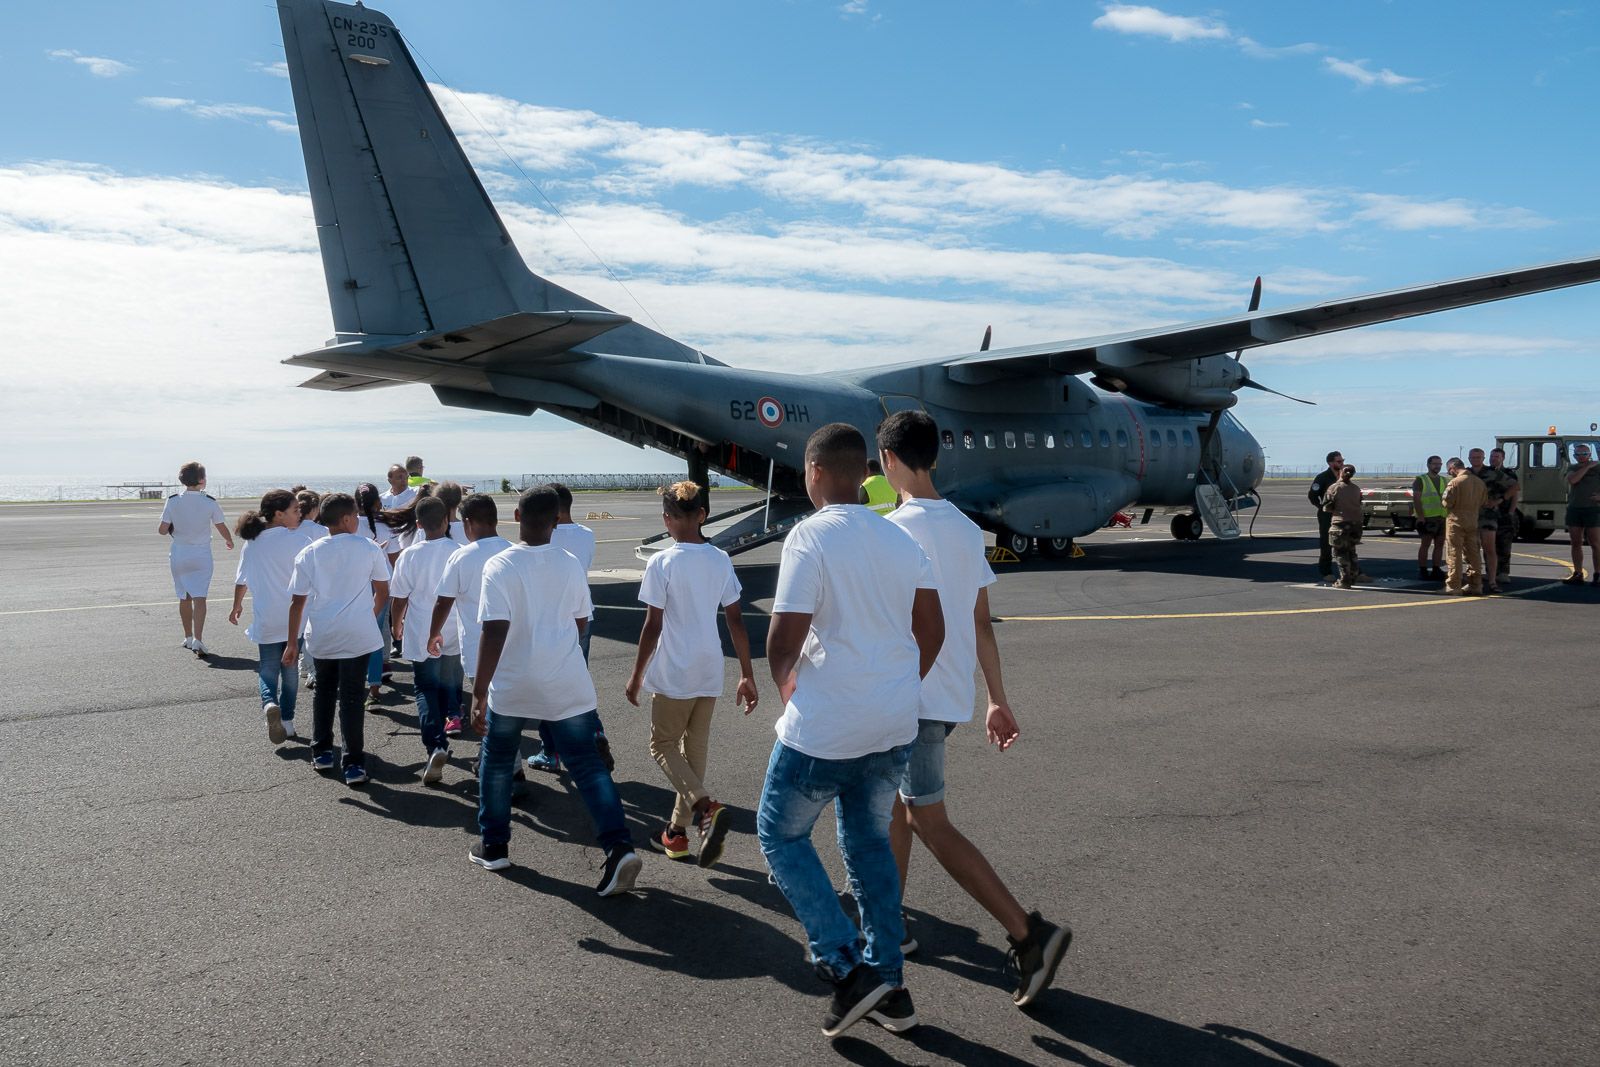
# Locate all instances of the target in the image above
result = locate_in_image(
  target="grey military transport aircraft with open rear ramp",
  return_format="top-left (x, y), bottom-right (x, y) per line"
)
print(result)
top-left (278, 0), bottom-right (1600, 555)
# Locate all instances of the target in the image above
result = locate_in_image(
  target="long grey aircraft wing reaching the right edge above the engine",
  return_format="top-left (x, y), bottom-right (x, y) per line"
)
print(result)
top-left (938, 256), bottom-right (1600, 381)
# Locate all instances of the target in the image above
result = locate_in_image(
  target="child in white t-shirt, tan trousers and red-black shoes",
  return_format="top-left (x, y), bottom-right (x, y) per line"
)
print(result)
top-left (626, 482), bottom-right (758, 867)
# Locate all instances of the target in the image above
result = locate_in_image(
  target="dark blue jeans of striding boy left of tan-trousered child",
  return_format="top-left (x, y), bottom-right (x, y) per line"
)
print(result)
top-left (478, 707), bottom-right (630, 857)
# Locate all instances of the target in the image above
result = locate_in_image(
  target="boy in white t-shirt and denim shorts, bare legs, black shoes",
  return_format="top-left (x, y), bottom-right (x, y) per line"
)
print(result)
top-left (878, 411), bottom-right (1072, 1008)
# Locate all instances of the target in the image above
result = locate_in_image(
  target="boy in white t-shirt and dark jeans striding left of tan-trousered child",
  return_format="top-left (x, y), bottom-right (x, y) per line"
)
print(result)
top-left (470, 485), bottom-right (642, 896)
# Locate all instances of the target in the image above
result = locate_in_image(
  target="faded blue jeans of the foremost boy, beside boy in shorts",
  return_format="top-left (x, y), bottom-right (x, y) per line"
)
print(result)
top-left (755, 741), bottom-right (912, 985)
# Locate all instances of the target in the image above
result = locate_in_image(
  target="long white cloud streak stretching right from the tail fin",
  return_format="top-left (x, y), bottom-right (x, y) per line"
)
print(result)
top-left (437, 86), bottom-right (1523, 238)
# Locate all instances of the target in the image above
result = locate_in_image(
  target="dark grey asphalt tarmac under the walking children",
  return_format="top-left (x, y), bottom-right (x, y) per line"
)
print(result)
top-left (0, 483), bottom-right (1600, 1067)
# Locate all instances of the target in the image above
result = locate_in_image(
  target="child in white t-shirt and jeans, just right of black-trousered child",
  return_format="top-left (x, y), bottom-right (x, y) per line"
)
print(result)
top-left (389, 496), bottom-right (461, 784)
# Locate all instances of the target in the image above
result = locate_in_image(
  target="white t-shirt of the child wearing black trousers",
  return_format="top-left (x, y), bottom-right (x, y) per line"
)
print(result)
top-left (290, 523), bottom-right (389, 659)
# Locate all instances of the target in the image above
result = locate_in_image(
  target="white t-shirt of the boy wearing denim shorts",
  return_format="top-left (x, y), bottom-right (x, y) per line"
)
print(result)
top-left (886, 499), bottom-right (995, 723)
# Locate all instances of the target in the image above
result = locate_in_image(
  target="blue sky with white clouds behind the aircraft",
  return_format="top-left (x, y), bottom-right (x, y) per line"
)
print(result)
top-left (0, 0), bottom-right (1600, 477)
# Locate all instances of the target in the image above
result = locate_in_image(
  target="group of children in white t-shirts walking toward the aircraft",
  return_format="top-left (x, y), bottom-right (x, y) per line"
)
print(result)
top-left (163, 422), bottom-right (1072, 1037)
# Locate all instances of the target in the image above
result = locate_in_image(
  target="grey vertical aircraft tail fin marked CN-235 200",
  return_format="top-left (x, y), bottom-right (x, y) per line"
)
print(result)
top-left (278, 0), bottom-right (704, 362)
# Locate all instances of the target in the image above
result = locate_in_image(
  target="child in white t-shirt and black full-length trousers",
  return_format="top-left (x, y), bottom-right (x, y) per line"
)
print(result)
top-left (283, 493), bottom-right (389, 785)
